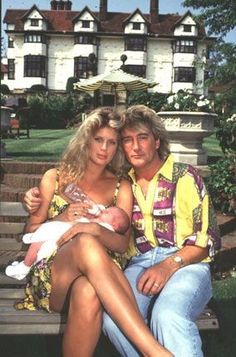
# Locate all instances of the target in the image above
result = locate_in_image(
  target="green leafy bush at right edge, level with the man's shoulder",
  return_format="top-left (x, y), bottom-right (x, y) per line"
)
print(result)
top-left (205, 155), bottom-right (236, 214)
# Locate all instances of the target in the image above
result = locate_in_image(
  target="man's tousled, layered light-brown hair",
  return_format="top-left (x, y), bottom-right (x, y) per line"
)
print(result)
top-left (121, 105), bottom-right (170, 160)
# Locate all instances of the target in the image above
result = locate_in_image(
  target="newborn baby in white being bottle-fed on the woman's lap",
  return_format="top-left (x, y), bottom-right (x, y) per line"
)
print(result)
top-left (5, 205), bottom-right (130, 280)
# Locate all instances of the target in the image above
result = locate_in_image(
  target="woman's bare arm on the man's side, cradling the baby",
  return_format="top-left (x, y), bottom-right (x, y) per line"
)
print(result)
top-left (58, 180), bottom-right (133, 253)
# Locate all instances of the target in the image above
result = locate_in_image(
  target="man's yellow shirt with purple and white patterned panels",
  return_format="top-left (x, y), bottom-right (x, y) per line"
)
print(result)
top-left (127, 155), bottom-right (220, 261)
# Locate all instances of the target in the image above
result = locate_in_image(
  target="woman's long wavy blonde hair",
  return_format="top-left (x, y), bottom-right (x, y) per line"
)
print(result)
top-left (59, 107), bottom-right (125, 186)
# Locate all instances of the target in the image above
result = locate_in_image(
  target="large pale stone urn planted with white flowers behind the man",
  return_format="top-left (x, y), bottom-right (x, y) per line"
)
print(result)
top-left (158, 90), bottom-right (217, 165)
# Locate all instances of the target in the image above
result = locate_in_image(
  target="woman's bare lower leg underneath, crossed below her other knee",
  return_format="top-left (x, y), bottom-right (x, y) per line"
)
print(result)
top-left (63, 277), bottom-right (103, 357)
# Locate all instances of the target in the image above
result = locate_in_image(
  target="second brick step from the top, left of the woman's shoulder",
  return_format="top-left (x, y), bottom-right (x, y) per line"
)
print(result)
top-left (2, 173), bottom-right (42, 190)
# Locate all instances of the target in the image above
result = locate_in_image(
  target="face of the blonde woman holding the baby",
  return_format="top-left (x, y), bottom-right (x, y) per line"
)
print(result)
top-left (89, 127), bottom-right (118, 166)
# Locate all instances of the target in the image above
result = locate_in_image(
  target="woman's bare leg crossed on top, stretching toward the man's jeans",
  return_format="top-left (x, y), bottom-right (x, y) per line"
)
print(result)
top-left (50, 234), bottom-right (171, 357)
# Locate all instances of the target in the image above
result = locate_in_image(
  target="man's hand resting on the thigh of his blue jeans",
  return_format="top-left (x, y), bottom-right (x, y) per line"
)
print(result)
top-left (137, 258), bottom-right (177, 295)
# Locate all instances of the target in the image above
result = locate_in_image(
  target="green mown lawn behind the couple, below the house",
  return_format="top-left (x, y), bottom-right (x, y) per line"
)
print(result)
top-left (3, 129), bottom-right (222, 161)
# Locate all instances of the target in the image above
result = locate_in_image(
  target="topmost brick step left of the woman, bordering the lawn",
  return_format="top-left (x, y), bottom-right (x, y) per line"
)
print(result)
top-left (1, 159), bottom-right (56, 175)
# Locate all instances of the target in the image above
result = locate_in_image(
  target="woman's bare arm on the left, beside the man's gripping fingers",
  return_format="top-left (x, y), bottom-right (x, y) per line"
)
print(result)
top-left (25, 169), bottom-right (57, 232)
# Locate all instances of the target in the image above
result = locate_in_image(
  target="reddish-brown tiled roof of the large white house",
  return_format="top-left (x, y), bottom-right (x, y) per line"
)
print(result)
top-left (3, 9), bottom-right (206, 37)
